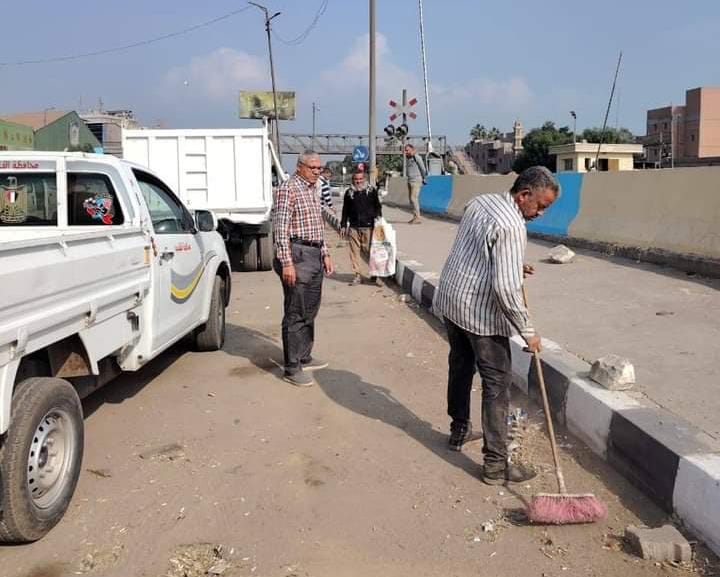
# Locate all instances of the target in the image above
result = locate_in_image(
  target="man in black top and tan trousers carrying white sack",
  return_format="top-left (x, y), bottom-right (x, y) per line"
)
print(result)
top-left (340, 172), bottom-right (382, 285)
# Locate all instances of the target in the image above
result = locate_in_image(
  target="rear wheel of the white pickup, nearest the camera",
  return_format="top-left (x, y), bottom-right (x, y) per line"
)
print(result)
top-left (0, 377), bottom-right (84, 543)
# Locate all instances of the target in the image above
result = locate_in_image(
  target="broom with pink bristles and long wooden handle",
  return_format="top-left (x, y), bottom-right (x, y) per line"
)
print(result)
top-left (523, 285), bottom-right (607, 525)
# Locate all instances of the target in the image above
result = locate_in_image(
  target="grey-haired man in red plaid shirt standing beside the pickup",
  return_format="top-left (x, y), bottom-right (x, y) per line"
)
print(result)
top-left (273, 152), bottom-right (333, 387)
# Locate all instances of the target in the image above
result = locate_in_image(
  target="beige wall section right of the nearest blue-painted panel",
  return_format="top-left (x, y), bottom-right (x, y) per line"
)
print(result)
top-left (569, 167), bottom-right (720, 258)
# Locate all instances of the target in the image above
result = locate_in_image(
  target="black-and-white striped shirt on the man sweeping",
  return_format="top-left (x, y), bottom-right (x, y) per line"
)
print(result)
top-left (433, 192), bottom-right (535, 338)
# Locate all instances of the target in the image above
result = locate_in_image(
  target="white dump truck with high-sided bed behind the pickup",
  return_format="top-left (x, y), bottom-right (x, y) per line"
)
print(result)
top-left (122, 128), bottom-right (285, 271)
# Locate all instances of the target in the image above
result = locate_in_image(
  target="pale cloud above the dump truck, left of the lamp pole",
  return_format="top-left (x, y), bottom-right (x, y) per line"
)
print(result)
top-left (164, 48), bottom-right (269, 102)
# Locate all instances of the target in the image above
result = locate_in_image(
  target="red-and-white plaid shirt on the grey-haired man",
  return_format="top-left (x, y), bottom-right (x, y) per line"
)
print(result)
top-left (273, 174), bottom-right (330, 266)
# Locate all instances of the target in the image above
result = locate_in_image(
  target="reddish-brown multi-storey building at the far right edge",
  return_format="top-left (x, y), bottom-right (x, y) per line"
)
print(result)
top-left (645, 86), bottom-right (720, 168)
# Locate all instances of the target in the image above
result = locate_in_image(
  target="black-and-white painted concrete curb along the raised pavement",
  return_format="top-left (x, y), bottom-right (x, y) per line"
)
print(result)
top-left (327, 214), bottom-right (720, 554)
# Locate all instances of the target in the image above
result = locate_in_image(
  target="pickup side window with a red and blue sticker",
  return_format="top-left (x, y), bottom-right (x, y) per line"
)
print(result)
top-left (67, 172), bottom-right (125, 226)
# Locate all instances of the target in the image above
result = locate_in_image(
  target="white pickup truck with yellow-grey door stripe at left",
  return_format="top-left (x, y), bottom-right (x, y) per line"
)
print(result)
top-left (0, 152), bottom-right (231, 542)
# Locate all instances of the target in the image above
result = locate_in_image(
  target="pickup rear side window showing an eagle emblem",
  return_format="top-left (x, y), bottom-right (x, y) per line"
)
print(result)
top-left (0, 172), bottom-right (57, 226)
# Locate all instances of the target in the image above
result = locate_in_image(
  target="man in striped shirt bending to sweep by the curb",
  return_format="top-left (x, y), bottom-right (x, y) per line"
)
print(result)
top-left (434, 166), bottom-right (560, 485)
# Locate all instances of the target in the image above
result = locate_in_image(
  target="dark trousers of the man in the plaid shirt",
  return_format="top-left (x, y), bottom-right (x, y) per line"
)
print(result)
top-left (274, 243), bottom-right (323, 374)
